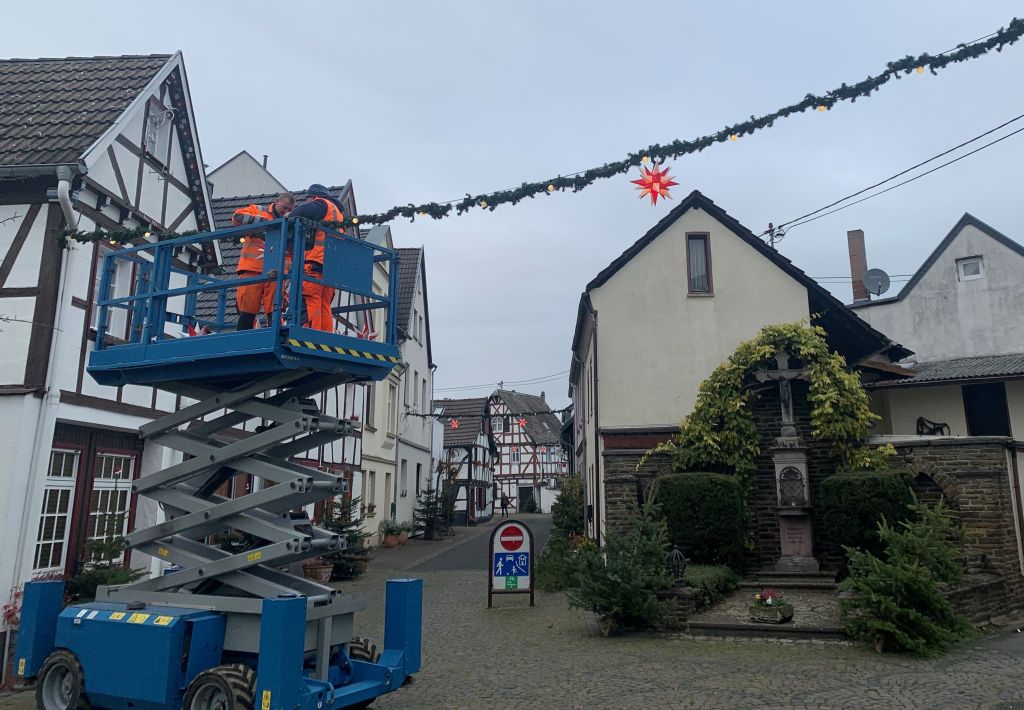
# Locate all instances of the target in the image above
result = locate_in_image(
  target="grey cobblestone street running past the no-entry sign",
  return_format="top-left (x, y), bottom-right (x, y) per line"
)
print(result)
top-left (0, 516), bottom-right (1024, 710)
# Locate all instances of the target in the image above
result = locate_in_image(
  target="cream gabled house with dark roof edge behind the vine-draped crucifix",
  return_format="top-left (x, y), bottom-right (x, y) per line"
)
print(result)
top-left (569, 191), bottom-right (905, 540)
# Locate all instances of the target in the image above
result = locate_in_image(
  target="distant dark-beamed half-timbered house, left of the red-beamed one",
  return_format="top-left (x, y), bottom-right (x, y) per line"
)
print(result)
top-left (434, 398), bottom-right (498, 525)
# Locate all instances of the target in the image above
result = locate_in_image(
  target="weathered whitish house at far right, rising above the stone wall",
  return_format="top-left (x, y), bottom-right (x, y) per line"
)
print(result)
top-left (850, 214), bottom-right (1024, 438)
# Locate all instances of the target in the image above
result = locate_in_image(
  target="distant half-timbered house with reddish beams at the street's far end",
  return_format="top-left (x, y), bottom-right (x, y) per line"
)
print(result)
top-left (489, 389), bottom-right (568, 512)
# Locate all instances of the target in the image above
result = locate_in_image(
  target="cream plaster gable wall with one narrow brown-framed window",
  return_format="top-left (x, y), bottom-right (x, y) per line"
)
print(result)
top-left (591, 204), bottom-right (809, 429)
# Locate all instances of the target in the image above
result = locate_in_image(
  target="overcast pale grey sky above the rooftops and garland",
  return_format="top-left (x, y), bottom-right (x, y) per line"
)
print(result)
top-left (9, 0), bottom-right (1024, 405)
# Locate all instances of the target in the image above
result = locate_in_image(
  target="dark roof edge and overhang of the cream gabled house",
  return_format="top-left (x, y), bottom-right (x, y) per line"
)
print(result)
top-left (569, 190), bottom-right (913, 391)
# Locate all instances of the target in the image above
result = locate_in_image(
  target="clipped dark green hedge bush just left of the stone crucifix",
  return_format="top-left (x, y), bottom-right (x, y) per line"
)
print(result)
top-left (658, 473), bottom-right (746, 570)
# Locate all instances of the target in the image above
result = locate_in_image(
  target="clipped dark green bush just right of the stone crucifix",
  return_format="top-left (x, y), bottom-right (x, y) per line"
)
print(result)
top-left (819, 471), bottom-right (913, 555)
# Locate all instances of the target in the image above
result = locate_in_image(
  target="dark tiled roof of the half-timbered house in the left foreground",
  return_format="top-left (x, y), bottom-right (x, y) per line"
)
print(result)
top-left (0, 54), bottom-right (171, 166)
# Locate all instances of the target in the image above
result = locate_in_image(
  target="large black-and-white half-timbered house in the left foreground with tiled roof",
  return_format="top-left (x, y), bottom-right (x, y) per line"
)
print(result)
top-left (0, 53), bottom-right (219, 600)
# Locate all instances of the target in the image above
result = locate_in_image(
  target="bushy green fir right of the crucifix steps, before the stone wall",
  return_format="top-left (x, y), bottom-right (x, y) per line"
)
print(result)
top-left (841, 502), bottom-right (970, 656)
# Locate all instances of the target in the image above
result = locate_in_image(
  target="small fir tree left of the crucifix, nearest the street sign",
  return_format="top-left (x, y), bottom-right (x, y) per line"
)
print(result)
top-left (568, 493), bottom-right (672, 636)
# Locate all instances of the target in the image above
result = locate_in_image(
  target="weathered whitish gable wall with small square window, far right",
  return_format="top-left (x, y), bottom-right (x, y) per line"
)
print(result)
top-left (854, 224), bottom-right (1024, 362)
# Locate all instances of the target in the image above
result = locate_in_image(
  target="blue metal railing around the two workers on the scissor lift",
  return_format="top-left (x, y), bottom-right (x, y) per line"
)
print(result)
top-left (95, 219), bottom-right (398, 350)
